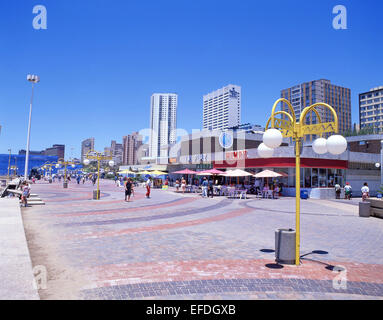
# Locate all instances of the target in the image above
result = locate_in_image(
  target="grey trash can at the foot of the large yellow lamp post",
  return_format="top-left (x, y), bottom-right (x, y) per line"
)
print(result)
top-left (275, 229), bottom-right (295, 264)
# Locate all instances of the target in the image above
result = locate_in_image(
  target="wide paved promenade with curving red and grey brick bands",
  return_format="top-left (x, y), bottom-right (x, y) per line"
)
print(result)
top-left (22, 181), bottom-right (383, 299)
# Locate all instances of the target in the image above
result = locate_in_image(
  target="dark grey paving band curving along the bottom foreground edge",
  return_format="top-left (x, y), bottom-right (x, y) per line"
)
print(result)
top-left (82, 279), bottom-right (383, 300)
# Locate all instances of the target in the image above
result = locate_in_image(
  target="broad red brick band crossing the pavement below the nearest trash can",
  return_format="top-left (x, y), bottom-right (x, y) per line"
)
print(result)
top-left (88, 259), bottom-right (383, 287)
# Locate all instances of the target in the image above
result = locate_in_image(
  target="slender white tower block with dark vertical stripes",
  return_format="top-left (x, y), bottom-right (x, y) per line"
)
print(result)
top-left (149, 93), bottom-right (178, 158)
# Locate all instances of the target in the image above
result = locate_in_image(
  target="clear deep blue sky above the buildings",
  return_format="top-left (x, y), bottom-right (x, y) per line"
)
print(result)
top-left (0, 0), bottom-right (383, 156)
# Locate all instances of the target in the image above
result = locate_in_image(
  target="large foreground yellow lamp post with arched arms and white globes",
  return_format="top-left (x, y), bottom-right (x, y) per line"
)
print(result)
top-left (258, 99), bottom-right (347, 265)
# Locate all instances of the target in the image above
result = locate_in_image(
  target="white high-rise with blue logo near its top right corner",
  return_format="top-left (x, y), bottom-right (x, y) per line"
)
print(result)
top-left (202, 84), bottom-right (241, 130)
